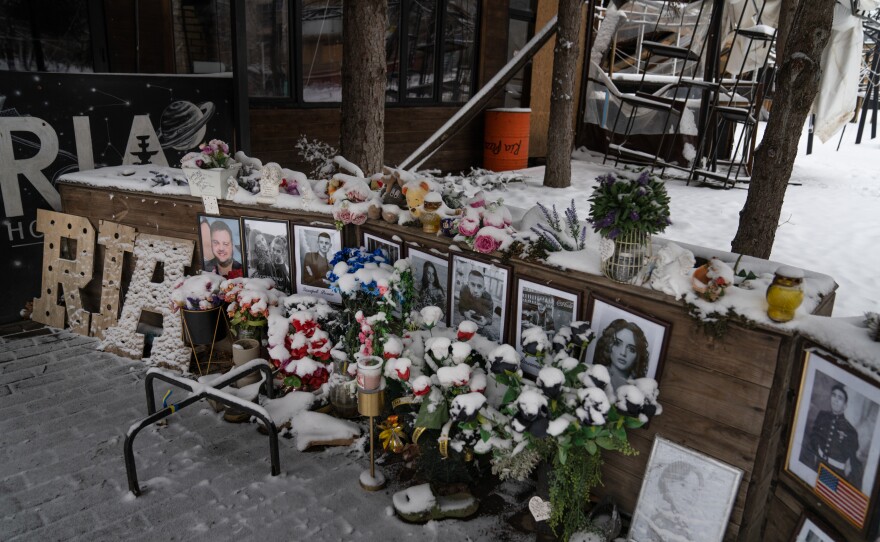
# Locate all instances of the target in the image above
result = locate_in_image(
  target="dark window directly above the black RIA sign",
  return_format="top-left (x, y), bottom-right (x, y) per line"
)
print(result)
top-left (0, 0), bottom-right (234, 73)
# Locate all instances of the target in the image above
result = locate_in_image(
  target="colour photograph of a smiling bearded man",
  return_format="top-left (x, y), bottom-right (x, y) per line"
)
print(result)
top-left (197, 213), bottom-right (244, 279)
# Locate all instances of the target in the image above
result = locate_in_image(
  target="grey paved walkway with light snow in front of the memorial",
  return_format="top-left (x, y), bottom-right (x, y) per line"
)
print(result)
top-left (0, 328), bottom-right (532, 541)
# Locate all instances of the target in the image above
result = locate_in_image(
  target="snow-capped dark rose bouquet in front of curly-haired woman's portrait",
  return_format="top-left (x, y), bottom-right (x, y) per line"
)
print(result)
top-left (484, 322), bottom-right (662, 540)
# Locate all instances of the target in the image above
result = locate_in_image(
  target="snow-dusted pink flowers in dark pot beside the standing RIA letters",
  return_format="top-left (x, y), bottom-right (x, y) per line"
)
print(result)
top-left (171, 272), bottom-right (227, 346)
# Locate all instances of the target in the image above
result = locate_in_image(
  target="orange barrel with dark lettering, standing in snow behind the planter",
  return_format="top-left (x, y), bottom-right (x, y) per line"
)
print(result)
top-left (483, 108), bottom-right (532, 171)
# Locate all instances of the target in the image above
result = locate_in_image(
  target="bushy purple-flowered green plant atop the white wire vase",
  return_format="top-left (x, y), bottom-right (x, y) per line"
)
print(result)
top-left (589, 170), bottom-right (672, 239)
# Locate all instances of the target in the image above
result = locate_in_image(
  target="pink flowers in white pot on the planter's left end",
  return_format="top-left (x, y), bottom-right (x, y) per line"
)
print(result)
top-left (180, 139), bottom-right (241, 199)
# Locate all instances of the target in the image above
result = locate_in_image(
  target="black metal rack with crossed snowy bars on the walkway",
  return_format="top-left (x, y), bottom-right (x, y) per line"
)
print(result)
top-left (124, 359), bottom-right (281, 497)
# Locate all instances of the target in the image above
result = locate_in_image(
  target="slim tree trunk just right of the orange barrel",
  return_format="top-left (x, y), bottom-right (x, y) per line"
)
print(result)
top-left (544, 0), bottom-right (583, 188)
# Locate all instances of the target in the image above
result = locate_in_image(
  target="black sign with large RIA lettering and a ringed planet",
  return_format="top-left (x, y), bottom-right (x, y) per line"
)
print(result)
top-left (0, 72), bottom-right (234, 323)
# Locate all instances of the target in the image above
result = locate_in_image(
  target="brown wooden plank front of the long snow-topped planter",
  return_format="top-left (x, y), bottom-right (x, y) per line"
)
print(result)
top-left (59, 183), bottom-right (840, 541)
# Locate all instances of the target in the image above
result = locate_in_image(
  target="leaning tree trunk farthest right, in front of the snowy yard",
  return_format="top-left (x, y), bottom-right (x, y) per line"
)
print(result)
top-left (731, 2), bottom-right (834, 259)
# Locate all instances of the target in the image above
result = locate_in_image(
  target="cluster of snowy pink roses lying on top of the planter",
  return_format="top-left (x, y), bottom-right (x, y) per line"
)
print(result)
top-left (455, 191), bottom-right (515, 254)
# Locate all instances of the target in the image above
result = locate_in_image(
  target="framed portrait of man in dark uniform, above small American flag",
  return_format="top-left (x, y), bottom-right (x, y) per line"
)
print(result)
top-left (788, 351), bottom-right (880, 495)
